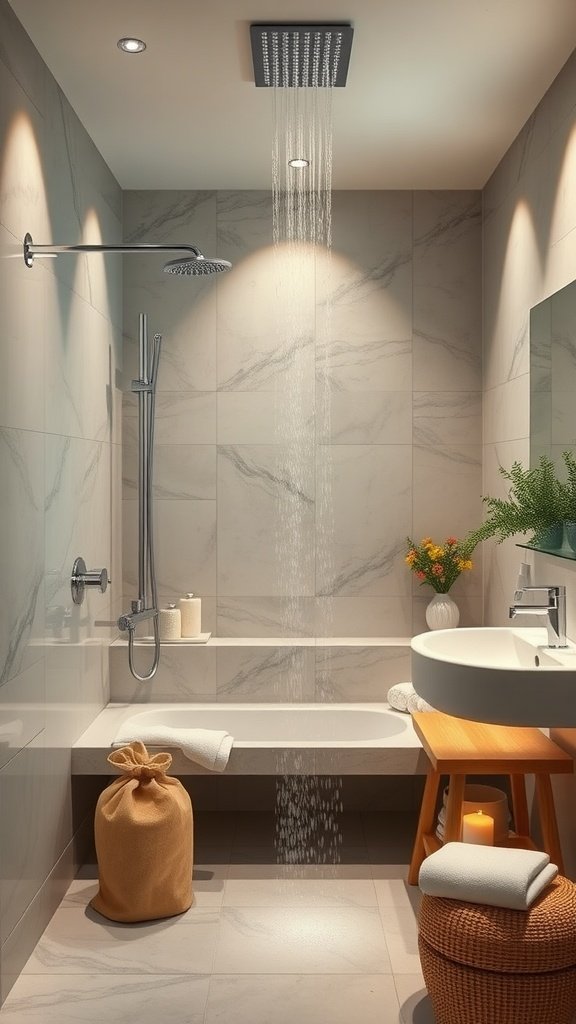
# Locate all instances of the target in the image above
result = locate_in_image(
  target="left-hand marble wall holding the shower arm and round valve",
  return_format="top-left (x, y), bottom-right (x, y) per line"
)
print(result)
top-left (0, 0), bottom-right (122, 996)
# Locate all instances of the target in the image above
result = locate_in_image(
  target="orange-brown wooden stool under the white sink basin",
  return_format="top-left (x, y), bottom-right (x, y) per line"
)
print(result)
top-left (408, 712), bottom-right (574, 886)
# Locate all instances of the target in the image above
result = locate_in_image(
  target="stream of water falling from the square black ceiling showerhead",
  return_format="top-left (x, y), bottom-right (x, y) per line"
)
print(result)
top-left (273, 88), bottom-right (343, 864)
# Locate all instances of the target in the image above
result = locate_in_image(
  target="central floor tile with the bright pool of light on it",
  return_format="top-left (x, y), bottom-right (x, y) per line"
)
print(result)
top-left (214, 906), bottom-right (390, 974)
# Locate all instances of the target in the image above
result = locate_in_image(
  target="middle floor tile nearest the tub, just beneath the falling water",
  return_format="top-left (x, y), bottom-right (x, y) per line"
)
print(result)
top-left (223, 863), bottom-right (376, 907)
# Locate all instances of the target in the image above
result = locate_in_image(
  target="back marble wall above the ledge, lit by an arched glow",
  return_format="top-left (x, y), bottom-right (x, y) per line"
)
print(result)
top-left (123, 191), bottom-right (482, 637)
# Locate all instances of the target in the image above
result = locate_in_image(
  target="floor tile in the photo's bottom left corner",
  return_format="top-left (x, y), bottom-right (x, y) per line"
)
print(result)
top-left (1, 974), bottom-right (209, 1024)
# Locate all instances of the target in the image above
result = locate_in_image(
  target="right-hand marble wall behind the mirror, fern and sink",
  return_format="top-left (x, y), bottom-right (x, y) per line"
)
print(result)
top-left (484, 53), bottom-right (576, 878)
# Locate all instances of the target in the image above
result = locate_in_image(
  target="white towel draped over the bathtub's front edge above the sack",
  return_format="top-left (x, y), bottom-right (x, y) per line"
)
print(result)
top-left (112, 720), bottom-right (234, 771)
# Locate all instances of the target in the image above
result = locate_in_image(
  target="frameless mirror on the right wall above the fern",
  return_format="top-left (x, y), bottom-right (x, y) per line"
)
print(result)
top-left (530, 282), bottom-right (576, 559)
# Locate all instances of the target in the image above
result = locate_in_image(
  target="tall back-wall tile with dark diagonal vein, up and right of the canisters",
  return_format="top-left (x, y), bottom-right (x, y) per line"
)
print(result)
top-left (218, 444), bottom-right (314, 597)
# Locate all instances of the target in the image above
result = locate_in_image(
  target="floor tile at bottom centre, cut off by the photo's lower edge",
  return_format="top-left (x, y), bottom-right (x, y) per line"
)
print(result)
top-left (206, 974), bottom-right (400, 1024)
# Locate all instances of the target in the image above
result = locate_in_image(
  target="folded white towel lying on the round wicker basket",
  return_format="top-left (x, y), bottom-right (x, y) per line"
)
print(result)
top-left (418, 843), bottom-right (558, 910)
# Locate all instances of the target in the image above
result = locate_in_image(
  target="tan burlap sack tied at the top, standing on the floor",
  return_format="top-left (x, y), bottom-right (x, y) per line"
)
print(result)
top-left (91, 740), bottom-right (193, 922)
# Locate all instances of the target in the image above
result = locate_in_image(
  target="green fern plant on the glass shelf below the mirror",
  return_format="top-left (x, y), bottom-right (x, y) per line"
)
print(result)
top-left (463, 452), bottom-right (565, 546)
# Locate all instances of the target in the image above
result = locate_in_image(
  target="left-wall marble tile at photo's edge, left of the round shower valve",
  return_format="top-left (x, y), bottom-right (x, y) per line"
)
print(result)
top-left (0, 428), bottom-right (44, 684)
